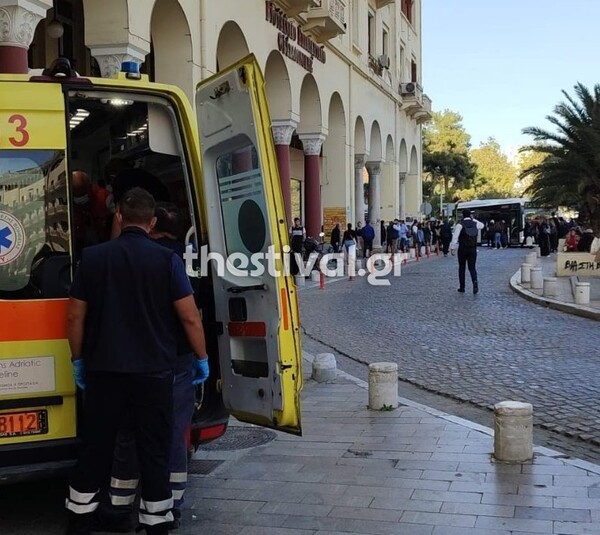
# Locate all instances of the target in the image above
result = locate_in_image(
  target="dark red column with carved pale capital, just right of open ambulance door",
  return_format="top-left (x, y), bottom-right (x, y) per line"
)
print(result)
top-left (299, 134), bottom-right (325, 237)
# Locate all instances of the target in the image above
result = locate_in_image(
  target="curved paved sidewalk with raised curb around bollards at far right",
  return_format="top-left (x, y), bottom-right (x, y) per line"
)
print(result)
top-left (510, 249), bottom-right (600, 321)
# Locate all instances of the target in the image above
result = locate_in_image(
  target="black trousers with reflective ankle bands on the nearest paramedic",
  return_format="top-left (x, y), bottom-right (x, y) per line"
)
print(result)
top-left (67, 371), bottom-right (173, 533)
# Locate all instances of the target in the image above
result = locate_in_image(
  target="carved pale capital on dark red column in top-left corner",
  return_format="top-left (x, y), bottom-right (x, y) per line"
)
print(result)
top-left (0, 0), bottom-right (52, 74)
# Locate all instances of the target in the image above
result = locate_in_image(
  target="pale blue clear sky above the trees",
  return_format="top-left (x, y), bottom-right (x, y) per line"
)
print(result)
top-left (422, 0), bottom-right (600, 155)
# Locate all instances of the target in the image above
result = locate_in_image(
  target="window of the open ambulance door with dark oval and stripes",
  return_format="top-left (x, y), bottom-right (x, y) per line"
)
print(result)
top-left (216, 144), bottom-right (268, 256)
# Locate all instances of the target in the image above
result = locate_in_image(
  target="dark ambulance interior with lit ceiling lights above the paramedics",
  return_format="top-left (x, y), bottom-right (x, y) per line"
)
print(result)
top-left (68, 91), bottom-right (197, 256)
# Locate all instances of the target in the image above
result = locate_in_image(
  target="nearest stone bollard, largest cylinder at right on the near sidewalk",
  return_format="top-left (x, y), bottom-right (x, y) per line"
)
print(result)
top-left (494, 401), bottom-right (533, 463)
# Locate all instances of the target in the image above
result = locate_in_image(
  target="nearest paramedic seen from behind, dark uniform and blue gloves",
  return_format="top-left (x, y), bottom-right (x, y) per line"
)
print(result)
top-left (66, 188), bottom-right (208, 535)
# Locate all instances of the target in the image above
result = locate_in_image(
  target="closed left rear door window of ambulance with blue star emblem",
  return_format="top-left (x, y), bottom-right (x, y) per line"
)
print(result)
top-left (0, 150), bottom-right (70, 299)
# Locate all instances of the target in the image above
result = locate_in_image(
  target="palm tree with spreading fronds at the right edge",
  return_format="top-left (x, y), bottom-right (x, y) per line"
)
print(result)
top-left (520, 83), bottom-right (600, 231)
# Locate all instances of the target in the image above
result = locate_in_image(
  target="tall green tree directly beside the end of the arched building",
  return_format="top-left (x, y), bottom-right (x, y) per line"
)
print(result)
top-left (423, 110), bottom-right (474, 199)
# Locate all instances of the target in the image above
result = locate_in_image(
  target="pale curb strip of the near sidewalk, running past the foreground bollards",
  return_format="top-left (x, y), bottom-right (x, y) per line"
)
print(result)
top-left (302, 354), bottom-right (600, 475)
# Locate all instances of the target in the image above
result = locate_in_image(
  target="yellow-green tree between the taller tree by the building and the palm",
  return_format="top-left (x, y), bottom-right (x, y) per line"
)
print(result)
top-left (460, 137), bottom-right (517, 199)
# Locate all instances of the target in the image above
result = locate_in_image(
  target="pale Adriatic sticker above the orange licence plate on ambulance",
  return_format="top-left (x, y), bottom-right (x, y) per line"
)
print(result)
top-left (0, 357), bottom-right (56, 394)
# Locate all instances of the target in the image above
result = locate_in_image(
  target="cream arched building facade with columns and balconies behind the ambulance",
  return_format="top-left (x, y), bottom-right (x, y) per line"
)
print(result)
top-left (0, 0), bottom-right (431, 245)
